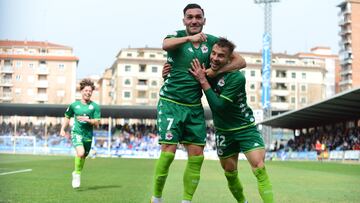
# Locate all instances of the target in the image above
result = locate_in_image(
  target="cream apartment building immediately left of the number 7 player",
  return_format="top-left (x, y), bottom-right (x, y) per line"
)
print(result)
top-left (108, 48), bottom-right (166, 106)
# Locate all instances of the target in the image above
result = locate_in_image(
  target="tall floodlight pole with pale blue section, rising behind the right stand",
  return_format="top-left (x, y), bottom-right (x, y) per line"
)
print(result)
top-left (254, 0), bottom-right (280, 149)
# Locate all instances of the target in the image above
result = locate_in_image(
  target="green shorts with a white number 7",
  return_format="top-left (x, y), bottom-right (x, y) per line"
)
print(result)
top-left (157, 98), bottom-right (206, 146)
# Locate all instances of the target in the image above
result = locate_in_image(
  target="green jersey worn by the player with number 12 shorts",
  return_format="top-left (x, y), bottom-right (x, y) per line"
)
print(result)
top-left (205, 71), bottom-right (255, 131)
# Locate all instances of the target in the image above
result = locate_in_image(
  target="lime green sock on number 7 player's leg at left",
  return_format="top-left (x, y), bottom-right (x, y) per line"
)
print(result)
top-left (153, 152), bottom-right (175, 197)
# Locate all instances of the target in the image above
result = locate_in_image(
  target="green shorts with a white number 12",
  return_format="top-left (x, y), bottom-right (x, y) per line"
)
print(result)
top-left (215, 127), bottom-right (265, 159)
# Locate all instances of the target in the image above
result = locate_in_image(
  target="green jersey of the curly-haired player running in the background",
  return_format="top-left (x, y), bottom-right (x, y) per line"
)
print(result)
top-left (65, 101), bottom-right (100, 141)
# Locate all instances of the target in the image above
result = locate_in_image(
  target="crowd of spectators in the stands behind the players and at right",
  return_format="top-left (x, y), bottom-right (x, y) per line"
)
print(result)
top-left (0, 122), bottom-right (360, 152)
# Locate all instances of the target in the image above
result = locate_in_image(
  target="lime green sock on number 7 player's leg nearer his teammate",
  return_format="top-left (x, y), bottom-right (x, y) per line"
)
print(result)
top-left (183, 155), bottom-right (204, 200)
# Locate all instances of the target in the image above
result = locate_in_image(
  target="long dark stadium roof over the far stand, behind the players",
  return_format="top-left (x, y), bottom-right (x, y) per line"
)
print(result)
top-left (0, 103), bottom-right (211, 119)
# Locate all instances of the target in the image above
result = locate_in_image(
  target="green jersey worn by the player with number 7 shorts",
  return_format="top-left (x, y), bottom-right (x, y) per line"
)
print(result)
top-left (160, 30), bottom-right (218, 104)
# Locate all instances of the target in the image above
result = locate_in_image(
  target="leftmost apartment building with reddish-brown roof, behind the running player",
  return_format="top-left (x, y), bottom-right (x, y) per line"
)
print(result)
top-left (0, 40), bottom-right (79, 104)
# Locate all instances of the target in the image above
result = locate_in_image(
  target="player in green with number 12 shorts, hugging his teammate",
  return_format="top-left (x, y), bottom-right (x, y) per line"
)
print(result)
top-left (190, 38), bottom-right (274, 203)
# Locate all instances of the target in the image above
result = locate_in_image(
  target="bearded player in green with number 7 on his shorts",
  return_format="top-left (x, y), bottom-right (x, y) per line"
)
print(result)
top-left (151, 4), bottom-right (245, 203)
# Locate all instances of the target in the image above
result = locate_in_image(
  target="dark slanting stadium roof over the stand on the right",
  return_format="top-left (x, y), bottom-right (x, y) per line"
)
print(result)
top-left (260, 88), bottom-right (360, 129)
